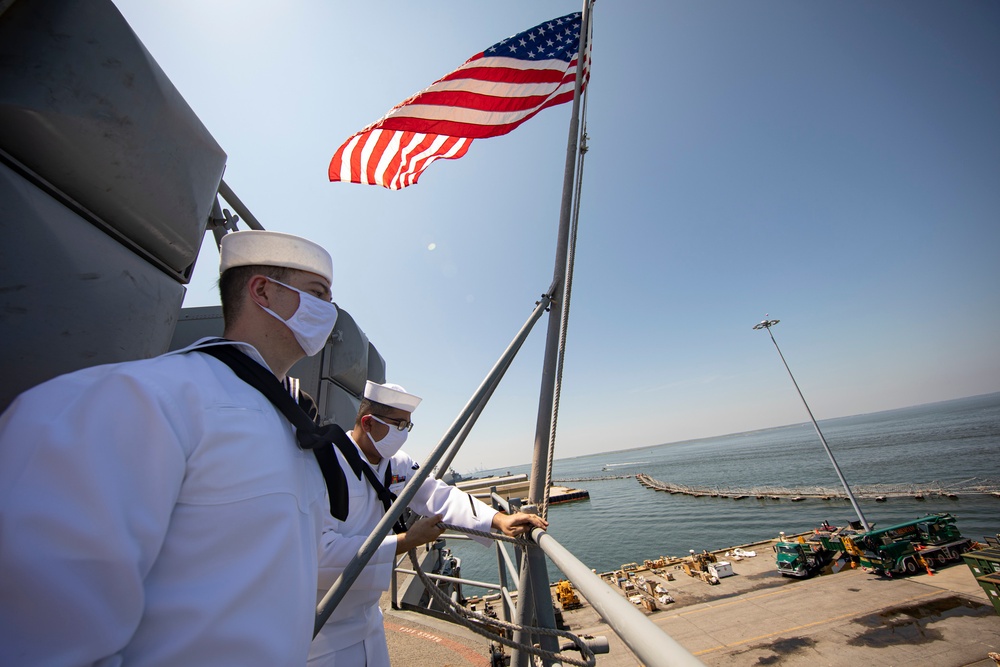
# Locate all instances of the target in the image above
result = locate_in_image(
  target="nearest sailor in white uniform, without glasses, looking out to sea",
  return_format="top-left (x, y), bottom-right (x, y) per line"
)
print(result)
top-left (0, 231), bottom-right (337, 667)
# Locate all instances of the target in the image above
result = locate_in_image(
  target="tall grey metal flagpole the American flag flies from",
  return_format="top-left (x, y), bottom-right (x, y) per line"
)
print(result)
top-left (511, 0), bottom-right (593, 667)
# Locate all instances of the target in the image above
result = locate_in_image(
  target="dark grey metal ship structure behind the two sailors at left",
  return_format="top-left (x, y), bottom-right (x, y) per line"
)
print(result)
top-left (0, 0), bottom-right (376, 426)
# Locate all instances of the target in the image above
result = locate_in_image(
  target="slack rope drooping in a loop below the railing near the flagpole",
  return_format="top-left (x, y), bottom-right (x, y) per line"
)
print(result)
top-left (407, 523), bottom-right (597, 667)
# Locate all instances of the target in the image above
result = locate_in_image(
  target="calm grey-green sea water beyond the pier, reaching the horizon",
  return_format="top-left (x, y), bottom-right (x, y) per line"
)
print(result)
top-left (448, 393), bottom-right (1000, 593)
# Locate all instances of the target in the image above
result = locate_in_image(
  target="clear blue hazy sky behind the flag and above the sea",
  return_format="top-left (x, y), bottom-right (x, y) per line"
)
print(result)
top-left (116, 0), bottom-right (1000, 471)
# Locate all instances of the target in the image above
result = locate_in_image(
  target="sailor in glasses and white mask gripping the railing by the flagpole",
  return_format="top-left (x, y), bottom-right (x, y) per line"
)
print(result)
top-left (309, 381), bottom-right (548, 667)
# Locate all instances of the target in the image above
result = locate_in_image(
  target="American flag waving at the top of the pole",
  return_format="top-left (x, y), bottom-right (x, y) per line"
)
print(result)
top-left (330, 12), bottom-right (589, 190)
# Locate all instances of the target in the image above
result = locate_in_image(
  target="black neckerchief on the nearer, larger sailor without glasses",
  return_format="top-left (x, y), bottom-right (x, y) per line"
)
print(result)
top-left (194, 338), bottom-right (350, 521)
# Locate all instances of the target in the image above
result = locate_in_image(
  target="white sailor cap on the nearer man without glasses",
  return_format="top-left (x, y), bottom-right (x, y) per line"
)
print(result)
top-left (219, 230), bottom-right (333, 283)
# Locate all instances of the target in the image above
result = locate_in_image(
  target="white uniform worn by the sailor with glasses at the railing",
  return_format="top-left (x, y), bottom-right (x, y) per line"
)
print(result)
top-left (309, 432), bottom-right (497, 667)
